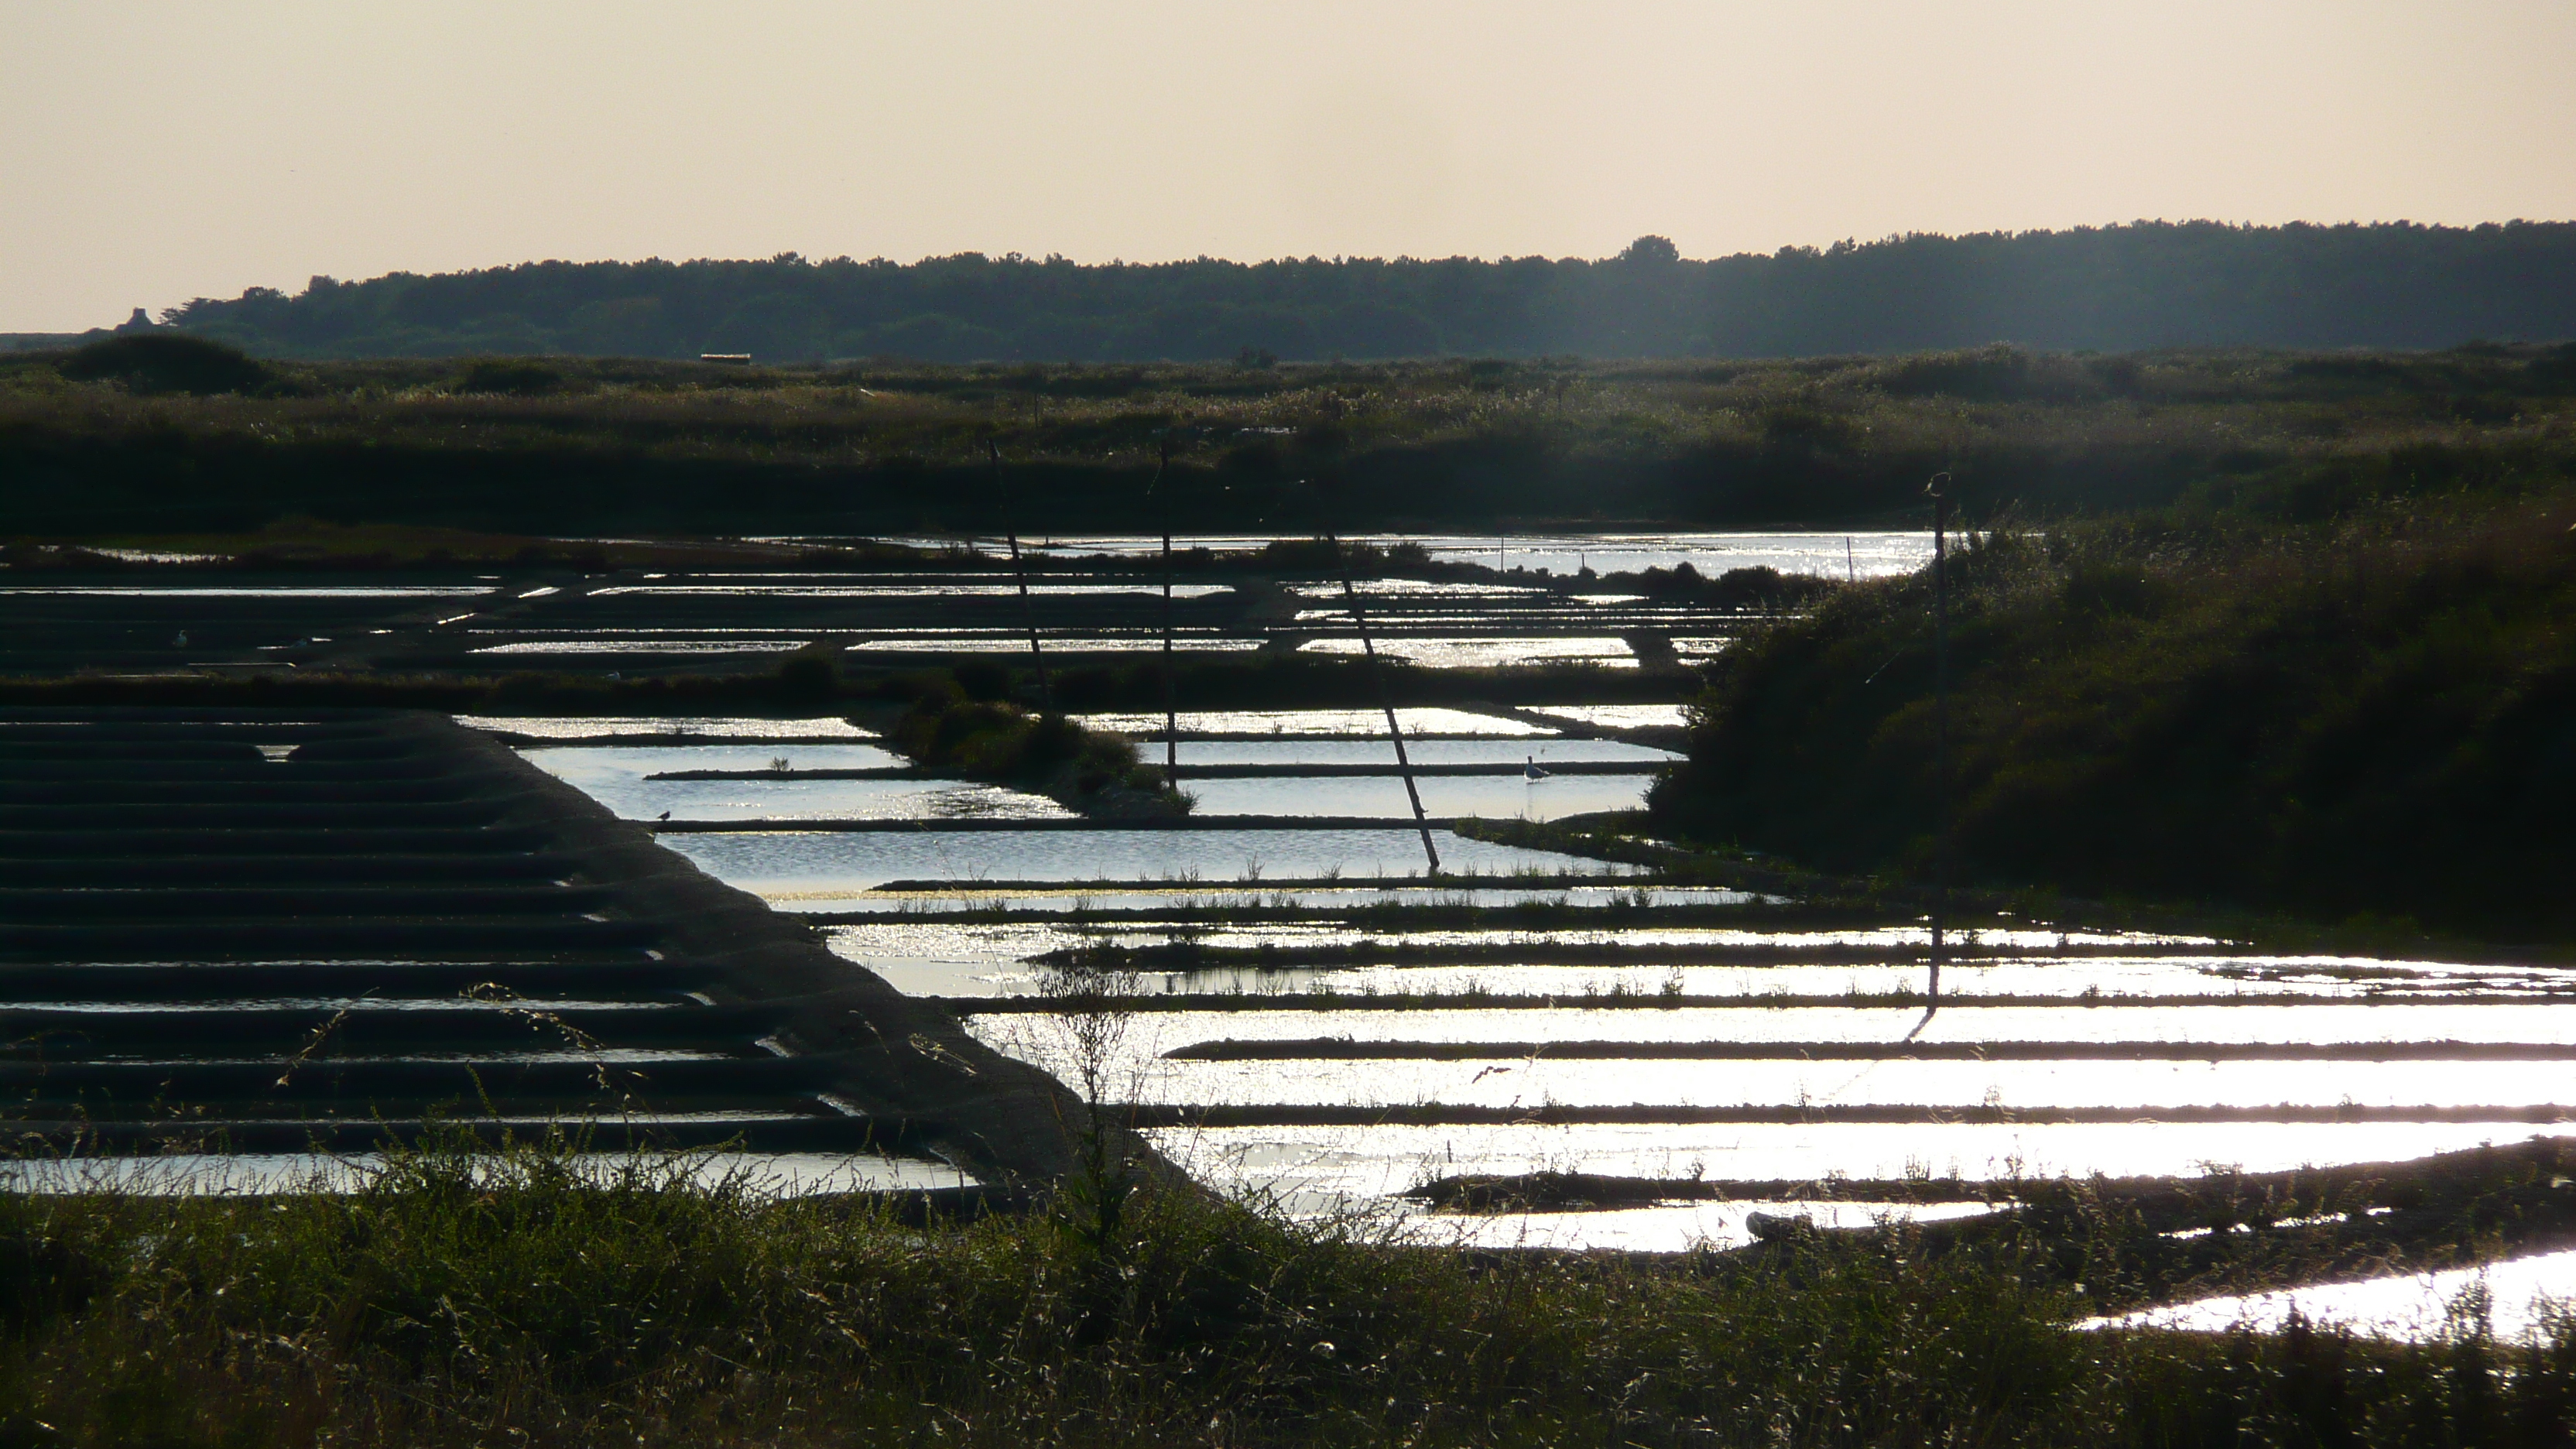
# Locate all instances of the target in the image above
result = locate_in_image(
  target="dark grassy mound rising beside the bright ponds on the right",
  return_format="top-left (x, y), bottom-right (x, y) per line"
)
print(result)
top-left (1651, 485), bottom-right (2576, 949)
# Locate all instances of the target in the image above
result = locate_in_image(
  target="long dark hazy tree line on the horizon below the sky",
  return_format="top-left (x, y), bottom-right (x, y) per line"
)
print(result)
top-left (163, 221), bottom-right (2576, 361)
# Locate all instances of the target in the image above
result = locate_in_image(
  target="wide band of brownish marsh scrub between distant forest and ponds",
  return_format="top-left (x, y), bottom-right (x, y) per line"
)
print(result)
top-left (0, 337), bottom-right (2576, 536)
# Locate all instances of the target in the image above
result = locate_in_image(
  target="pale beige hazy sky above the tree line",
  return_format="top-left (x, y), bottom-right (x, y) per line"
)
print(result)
top-left (0, 0), bottom-right (2576, 330)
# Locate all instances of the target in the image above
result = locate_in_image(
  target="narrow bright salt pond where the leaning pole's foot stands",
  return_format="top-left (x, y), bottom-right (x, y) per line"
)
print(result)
top-left (662, 827), bottom-right (1633, 895)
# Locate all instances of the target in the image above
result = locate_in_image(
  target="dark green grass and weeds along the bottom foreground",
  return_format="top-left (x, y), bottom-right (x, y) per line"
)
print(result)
top-left (0, 1150), bottom-right (2576, 1447)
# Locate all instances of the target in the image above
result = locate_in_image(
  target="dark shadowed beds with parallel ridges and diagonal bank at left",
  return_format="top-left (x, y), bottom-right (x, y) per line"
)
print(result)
top-left (0, 709), bottom-right (1079, 1186)
